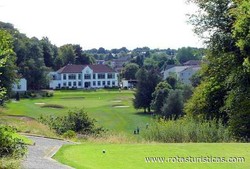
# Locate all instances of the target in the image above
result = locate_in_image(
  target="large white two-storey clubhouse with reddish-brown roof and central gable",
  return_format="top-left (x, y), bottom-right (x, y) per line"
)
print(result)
top-left (49, 64), bottom-right (118, 89)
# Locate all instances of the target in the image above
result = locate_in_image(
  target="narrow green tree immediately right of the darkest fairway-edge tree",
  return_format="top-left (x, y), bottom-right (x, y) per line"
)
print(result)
top-left (151, 81), bottom-right (171, 114)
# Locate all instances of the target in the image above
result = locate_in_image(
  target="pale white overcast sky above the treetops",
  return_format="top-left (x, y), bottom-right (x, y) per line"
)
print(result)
top-left (0, 0), bottom-right (202, 49)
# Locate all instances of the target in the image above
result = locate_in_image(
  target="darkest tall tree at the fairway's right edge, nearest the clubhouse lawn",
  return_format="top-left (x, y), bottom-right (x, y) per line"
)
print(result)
top-left (133, 68), bottom-right (160, 112)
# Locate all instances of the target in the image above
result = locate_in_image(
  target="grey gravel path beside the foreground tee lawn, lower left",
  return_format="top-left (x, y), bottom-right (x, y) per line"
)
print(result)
top-left (22, 136), bottom-right (72, 169)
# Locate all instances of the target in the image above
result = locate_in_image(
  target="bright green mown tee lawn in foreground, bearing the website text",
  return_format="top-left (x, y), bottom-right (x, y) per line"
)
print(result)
top-left (53, 143), bottom-right (250, 169)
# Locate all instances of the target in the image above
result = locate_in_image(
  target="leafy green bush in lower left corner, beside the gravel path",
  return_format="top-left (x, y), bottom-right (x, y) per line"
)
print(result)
top-left (0, 126), bottom-right (27, 158)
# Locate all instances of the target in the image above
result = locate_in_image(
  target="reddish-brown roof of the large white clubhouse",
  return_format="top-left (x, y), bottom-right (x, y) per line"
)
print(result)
top-left (57, 64), bottom-right (115, 73)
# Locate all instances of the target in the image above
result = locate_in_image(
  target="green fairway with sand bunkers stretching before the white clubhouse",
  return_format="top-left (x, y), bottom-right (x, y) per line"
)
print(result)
top-left (3, 90), bottom-right (151, 133)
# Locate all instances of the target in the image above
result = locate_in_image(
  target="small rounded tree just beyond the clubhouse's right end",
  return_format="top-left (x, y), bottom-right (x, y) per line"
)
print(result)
top-left (122, 63), bottom-right (139, 80)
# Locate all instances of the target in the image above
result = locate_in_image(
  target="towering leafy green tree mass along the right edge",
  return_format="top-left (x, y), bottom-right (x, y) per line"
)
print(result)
top-left (185, 0), bottom-right (250, 140)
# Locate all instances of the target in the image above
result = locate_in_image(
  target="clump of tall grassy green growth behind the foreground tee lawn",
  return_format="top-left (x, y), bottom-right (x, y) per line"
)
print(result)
top-left (144, 118), bottom-right (234, 143)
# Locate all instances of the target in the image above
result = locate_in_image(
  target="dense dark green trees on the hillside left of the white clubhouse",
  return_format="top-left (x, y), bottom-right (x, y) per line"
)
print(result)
top-left (0, 22), bottom-right (95, 94)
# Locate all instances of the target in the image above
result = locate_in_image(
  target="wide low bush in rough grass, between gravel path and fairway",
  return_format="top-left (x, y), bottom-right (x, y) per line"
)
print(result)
top-left (39, 109), bottom-right (104, 135)
